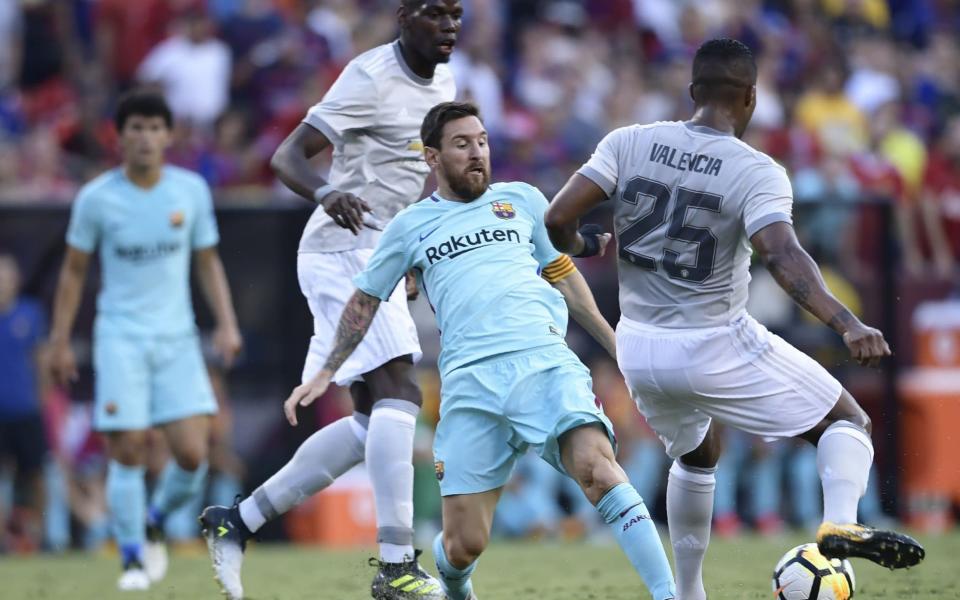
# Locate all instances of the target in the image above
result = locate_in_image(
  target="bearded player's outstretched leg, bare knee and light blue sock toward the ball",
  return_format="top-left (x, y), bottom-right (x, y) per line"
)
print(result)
top-left (560, 423), bottom-right (676, 600)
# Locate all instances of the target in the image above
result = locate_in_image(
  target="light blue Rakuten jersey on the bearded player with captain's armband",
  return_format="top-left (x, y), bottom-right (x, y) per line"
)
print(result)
top-left (354, 182), bottom-right (567, 374)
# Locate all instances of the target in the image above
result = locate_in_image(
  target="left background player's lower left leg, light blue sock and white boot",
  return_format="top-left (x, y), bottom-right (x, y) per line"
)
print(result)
top-left (107, 460), bottom-right (150, 591)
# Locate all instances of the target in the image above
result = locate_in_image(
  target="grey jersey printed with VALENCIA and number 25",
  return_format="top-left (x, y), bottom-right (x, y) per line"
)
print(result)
top-left (579, 121), bottom-right (793, 328)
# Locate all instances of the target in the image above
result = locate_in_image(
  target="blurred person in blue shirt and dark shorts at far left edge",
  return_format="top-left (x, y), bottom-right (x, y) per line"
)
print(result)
top-left (0, 254), bottom-right (47, 552)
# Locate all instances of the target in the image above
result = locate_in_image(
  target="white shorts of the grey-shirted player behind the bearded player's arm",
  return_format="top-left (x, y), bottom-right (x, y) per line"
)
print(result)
top-left (297, 248), bottom-right (421, 385)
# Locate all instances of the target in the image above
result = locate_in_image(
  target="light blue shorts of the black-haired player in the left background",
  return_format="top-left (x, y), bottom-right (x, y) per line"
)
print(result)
top-left (93, 335), bottom-right (217, 431)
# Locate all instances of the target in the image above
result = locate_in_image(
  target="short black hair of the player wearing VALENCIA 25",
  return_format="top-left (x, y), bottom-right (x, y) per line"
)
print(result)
top-left (693, 38), bottom-right (757, 98)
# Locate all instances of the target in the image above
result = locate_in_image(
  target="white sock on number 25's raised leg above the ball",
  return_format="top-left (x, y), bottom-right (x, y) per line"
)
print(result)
top-left (817, 421), bottom-right (873, 523)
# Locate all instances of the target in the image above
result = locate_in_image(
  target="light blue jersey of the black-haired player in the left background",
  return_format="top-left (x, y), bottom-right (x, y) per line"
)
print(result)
top-left (67, 166), bottom-right (219, 337)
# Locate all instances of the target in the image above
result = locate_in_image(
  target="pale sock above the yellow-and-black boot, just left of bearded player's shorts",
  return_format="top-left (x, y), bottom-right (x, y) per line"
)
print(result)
top-left (366, 399), bottom-right (420, 563)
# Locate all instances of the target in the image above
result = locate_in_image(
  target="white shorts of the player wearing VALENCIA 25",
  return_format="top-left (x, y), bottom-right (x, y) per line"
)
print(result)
top-left (617, 315), bottom-right (843, 458)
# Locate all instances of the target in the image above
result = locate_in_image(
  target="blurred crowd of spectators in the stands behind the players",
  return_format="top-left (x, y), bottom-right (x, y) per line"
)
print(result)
top-left (0, 0), bottom-right (960, 278)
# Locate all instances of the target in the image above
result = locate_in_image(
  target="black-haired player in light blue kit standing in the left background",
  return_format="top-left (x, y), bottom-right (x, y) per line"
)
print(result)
top-left (51, 93), bottom-right (241, 590)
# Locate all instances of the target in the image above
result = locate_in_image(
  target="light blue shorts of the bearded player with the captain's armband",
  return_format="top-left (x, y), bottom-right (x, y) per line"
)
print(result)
top-left (433, 345), bottom-right (616, 496)
